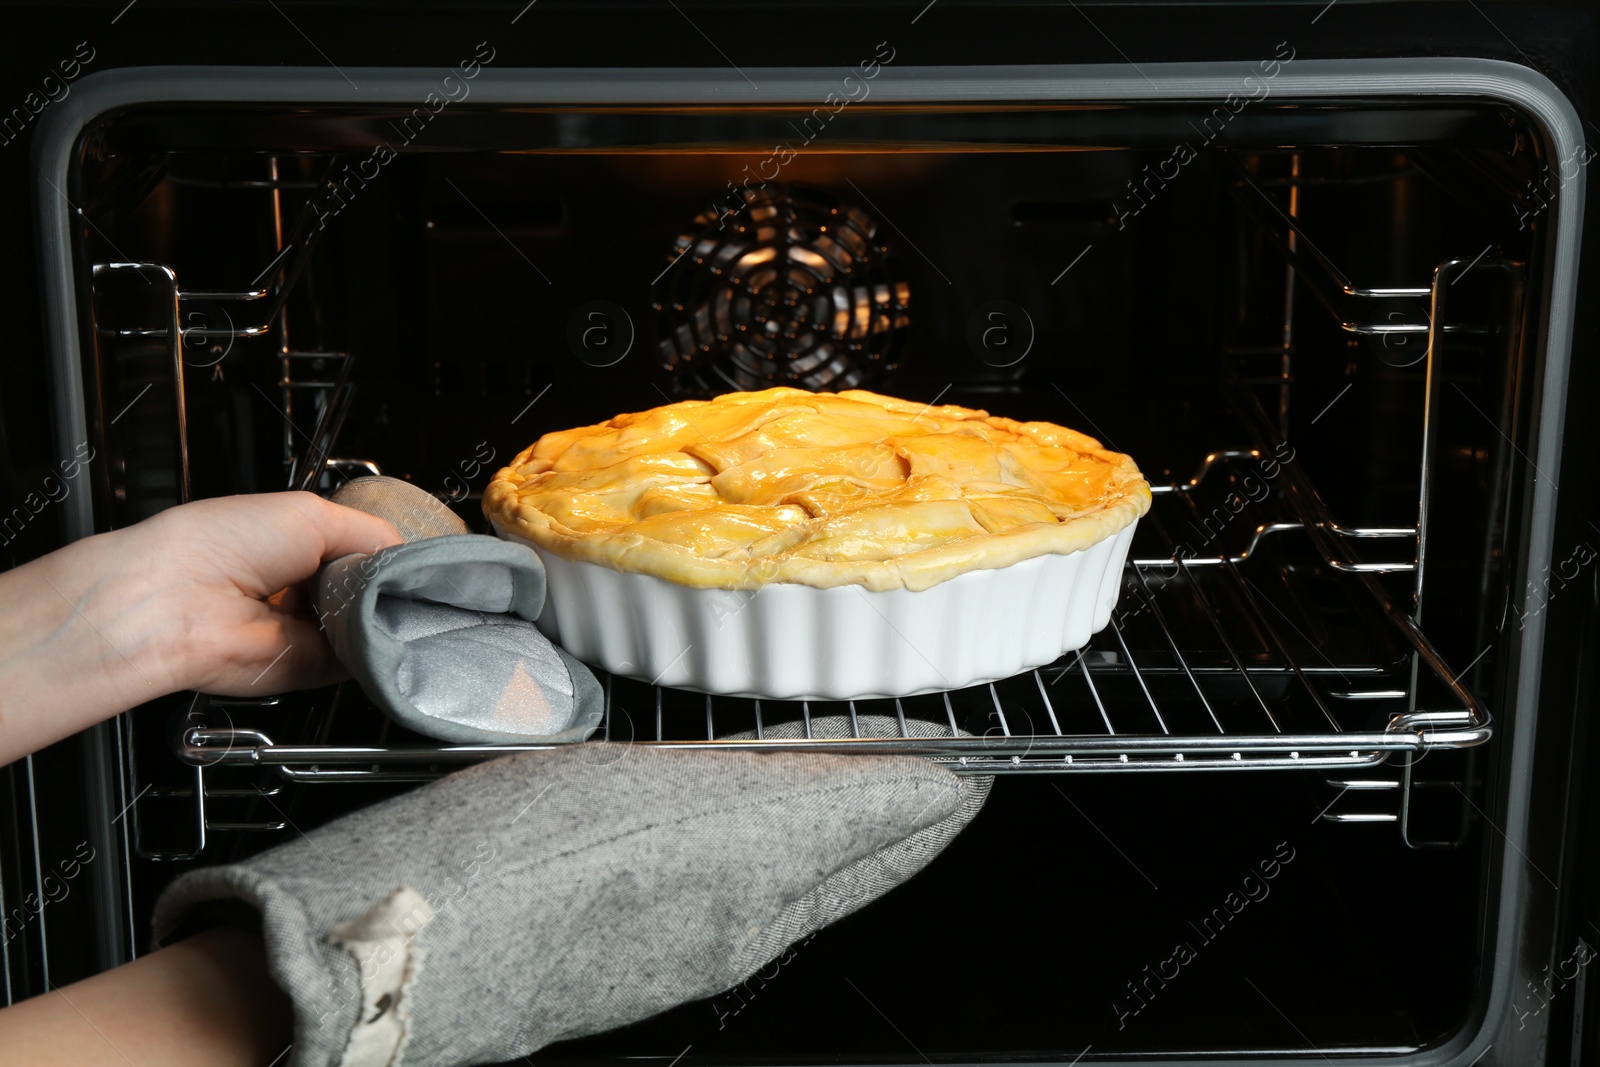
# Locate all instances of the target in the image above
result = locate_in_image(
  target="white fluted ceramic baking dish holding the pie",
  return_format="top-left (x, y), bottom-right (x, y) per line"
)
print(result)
top-left (499, 523), bottom-right (1138, 701)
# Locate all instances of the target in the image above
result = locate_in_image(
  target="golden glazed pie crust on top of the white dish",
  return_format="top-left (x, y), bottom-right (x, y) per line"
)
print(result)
top-left (483, 389), bottom-right (1150, 590)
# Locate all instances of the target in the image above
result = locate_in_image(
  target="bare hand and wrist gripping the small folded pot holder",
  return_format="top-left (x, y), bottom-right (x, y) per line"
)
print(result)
top-left (0, 493), bottom-right (400, 763)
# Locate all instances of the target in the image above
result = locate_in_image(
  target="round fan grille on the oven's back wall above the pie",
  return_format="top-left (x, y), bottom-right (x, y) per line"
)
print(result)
top-left (653, 186), bottom-right (910, 395)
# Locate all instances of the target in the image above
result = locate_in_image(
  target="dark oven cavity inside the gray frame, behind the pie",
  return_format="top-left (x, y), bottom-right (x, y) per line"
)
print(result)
top-left (5, 89), bottom-right (1546, 1064)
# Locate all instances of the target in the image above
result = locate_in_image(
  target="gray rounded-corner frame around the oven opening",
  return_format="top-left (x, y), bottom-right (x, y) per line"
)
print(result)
top-left (30, 58), bottom-right (1584, 1065)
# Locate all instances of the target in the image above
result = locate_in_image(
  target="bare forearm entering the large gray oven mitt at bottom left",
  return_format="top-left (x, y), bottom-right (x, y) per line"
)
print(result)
top-left (0, 928), bottom-right (293, 1067)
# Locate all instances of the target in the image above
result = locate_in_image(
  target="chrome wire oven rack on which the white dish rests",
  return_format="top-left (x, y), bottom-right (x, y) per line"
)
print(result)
top-left (174, 450), bottom-right (1491, 782)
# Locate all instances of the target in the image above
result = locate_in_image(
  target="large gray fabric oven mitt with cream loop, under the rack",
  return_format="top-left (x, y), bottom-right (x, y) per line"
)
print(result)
top-left (154, 720), bottom-right (989, 1067)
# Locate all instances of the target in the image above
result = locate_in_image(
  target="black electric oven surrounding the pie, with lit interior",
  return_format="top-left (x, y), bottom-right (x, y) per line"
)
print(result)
top-left (0, 0), bottom-right (1600, 1065)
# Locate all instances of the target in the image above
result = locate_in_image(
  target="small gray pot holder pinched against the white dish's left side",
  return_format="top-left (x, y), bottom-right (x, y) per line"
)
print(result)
top-left (314, 477), bottom-right (605, 744)
